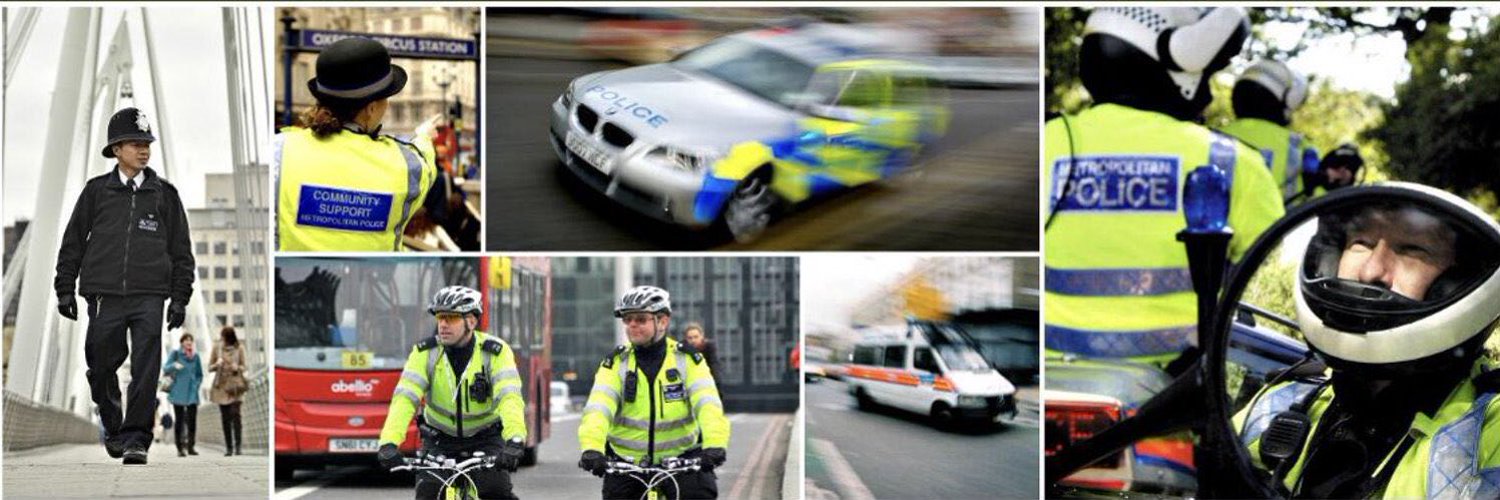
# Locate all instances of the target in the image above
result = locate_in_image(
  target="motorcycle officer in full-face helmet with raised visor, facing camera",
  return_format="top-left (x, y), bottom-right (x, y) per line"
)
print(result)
top-left (1233, 185), bottom-right (1500, 498)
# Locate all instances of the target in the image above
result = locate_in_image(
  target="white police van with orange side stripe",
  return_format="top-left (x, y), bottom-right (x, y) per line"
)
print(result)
top-left (845, 321), bottom-right (1016, 425)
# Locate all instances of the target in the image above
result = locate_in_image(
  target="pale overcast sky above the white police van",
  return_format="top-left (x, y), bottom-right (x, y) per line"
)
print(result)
top-left (801, 254), bottom-right (920, 332)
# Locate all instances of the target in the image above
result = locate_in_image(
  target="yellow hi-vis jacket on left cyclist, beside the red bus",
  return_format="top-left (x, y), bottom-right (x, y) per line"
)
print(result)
top-left (380, 332), bottom-right (527, 444)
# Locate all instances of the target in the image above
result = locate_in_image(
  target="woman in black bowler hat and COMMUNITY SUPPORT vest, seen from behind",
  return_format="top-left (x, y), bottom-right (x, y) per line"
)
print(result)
top-left (272, 38), bottom-right (438, 251)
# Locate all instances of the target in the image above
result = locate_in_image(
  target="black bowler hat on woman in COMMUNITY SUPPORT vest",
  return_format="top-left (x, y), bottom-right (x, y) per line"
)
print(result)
top-left (308, 38), bottom-right (407, 105)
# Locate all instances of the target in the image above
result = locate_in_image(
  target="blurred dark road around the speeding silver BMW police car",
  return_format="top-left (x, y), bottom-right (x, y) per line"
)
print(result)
top-left (485, 18), bottom-right (1040, 251)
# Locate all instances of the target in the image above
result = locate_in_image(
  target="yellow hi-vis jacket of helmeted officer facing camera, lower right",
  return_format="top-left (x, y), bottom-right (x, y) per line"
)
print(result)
top-left (1233, 360), bottom-right (1500, 498)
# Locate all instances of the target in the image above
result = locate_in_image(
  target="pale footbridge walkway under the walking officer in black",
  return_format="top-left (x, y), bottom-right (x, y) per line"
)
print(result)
top-left (5, 443), bottom-right (270, 498)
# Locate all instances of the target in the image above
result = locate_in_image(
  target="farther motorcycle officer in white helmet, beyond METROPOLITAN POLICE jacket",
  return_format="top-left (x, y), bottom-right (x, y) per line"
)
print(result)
top-left (1223, 60), bottom-right (1317, 204)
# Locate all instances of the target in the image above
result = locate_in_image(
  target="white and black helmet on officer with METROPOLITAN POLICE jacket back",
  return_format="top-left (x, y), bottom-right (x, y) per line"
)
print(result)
top-left (1079, 8), bottom-right (1250, 120)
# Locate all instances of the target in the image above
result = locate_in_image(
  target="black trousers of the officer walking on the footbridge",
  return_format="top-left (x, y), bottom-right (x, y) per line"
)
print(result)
top-left (84, 296), bottom-right (167, 447)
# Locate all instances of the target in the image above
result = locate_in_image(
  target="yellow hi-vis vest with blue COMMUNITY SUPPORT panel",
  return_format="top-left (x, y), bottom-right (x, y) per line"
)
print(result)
top-left (272, 126), bottom-right (438, 252)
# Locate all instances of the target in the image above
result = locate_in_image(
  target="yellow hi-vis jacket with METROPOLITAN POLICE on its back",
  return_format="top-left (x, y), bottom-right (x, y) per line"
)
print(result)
top-left (1043, 104), bottom-right (1284, 362)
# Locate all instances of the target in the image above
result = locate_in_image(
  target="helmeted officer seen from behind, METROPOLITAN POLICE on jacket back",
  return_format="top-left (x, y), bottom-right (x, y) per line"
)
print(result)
top-left (1044, 8), bottom-right (1284, 365)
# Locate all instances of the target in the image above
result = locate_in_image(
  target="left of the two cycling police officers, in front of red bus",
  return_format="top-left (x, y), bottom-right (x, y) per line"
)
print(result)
top-left (378, 287), bottom-right (527, 498)
